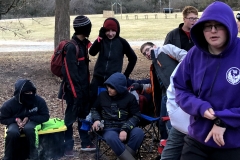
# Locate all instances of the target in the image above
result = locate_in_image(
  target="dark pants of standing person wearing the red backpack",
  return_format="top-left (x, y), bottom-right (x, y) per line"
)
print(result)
top-left (64, 92), bottom-right (91, 151)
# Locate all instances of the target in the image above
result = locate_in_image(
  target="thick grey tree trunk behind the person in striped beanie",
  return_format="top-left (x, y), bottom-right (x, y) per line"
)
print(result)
top-left (54, 0), bottom-right (70, 48)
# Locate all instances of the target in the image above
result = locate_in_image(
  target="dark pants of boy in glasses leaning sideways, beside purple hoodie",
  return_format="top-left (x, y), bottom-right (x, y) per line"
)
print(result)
top-left (159, 95), bottom-right (172, 139)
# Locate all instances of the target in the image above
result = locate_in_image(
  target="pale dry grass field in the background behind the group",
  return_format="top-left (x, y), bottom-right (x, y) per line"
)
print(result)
top-left (0, 11), bottom-right (240, 41)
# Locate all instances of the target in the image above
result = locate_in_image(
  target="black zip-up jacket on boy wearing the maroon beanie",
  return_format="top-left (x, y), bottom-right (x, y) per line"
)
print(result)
top-left (89, 18), bottom-right (137, 80)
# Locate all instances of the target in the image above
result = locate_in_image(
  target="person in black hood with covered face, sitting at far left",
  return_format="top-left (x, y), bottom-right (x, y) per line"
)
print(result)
top-left (0, 79), bottom-right (49, 160)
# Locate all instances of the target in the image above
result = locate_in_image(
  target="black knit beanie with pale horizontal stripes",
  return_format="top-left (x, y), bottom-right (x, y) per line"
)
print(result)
top-left (73, 16), bottom-right (92, 37)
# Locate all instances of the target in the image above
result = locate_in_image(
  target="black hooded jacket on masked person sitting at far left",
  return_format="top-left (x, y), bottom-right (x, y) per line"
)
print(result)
top-left (0, 79), bottom-right (50, 125)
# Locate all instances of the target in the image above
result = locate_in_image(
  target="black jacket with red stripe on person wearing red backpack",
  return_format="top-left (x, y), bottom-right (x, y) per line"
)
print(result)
top-left (59, 35), bottom-right (91, 101)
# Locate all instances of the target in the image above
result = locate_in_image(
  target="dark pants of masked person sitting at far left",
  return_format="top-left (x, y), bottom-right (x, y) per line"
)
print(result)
top-left (3, 121), bottom-right (38, 160)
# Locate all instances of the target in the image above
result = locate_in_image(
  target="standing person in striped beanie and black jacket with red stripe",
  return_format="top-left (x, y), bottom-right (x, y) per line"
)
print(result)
top-left (59, 16), bottom-right (96, 157)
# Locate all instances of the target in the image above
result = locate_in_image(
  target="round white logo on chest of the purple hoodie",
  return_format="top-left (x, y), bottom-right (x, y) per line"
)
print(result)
top-left (226, 67), bottom-right (240, 85)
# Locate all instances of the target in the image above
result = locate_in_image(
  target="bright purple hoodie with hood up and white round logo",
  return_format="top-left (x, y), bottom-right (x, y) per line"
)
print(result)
top-left (173, 1), bottom-right (240, 148)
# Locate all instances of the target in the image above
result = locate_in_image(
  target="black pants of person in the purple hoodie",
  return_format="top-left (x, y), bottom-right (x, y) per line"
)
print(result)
top-left (181, 136), bottom-right (240, 160)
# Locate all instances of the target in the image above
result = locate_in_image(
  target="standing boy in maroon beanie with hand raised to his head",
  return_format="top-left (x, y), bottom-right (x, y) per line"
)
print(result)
top-left (89, 18), bottom-right (137, 109)
